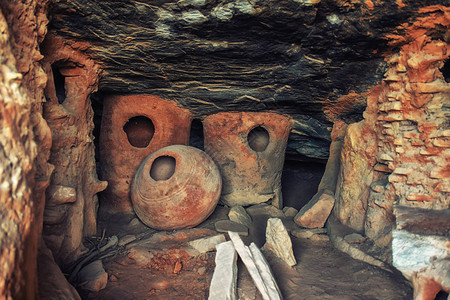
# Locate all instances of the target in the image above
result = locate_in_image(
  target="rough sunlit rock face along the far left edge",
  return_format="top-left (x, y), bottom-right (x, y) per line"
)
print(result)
top-left (0, 0), bottom-right (53, 299)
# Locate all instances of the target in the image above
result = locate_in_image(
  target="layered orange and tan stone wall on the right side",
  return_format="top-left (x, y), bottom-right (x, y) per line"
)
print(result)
top-left (333, 6), bottom-right (450, 259)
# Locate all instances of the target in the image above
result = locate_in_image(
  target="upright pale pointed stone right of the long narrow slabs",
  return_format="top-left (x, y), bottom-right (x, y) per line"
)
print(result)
top-left (263, 218), bottom-right (297, 267)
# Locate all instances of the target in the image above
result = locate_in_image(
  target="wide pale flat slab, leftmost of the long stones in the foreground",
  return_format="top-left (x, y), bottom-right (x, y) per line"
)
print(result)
top-left (208, 241), bottom-right (237, 300)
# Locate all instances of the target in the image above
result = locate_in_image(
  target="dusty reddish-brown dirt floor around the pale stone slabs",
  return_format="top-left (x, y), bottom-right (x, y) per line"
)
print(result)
top-left (88, 207), bottom-right (412, 300)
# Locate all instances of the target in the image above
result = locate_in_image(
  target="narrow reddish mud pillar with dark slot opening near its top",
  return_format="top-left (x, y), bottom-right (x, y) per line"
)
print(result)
top-left (42, 34), bottom-right (107, 268)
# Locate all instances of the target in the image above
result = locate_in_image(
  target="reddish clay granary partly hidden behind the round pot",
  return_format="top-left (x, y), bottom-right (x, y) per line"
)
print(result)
top-left (99, 95), bottom-right (192, 214)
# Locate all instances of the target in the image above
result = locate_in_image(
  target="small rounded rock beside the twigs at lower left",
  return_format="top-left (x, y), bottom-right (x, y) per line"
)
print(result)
top-left (78, 260), bottom-right (108, 292)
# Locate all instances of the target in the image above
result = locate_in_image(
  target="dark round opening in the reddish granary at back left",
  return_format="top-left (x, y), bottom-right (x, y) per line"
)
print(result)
top-left (123, 116), bottom-right (155, 148)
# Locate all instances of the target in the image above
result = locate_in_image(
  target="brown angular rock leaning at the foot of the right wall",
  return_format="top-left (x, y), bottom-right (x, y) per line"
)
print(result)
top-left (294, 191), bottom-right (334, 228)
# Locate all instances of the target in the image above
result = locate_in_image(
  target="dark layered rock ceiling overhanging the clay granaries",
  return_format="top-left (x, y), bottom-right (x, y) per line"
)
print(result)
top-left (49, 0), bottom-right (441, 160)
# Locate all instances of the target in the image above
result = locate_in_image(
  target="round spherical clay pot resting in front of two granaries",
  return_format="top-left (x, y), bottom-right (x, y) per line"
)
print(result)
top-left (131, 145), bottom-right (222, 230)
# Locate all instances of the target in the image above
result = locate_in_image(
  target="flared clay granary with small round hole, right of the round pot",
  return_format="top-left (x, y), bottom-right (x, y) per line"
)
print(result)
top-left (203, 112), bottom-right (293, 208)
